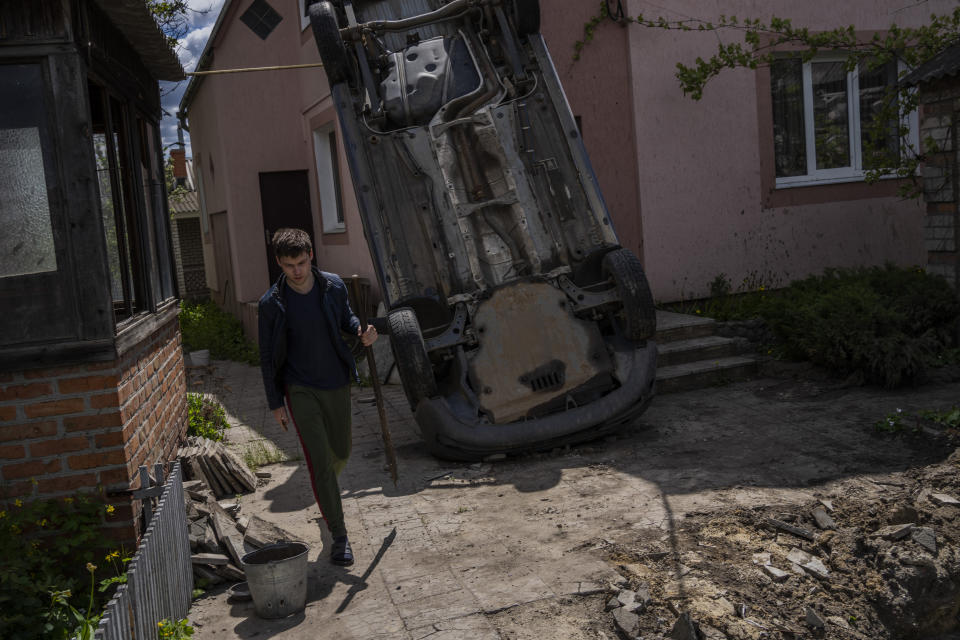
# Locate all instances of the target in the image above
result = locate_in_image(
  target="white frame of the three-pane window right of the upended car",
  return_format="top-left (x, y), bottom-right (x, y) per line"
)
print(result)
top-left (776, 54), bottom-right (920, 189)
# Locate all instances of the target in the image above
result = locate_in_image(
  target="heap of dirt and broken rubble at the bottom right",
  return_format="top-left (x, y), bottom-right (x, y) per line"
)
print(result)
top-left (606, 450), bottom-right (960, 640)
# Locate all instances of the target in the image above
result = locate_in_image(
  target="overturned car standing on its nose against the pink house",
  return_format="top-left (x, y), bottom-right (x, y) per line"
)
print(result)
top-left (308, 0), bottom-right (656, 459)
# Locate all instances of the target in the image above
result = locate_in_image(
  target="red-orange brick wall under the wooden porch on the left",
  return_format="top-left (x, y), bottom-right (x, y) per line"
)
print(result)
top-left (0, 315), bottom-right (187, 542)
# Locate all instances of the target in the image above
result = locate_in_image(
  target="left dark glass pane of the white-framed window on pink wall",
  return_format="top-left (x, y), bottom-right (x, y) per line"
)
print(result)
top-left (770, 60), bottom-right (807, 178)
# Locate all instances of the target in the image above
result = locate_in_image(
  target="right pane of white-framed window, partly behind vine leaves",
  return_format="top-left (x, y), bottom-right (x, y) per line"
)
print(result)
top-left (859, 62), bottom-right (900, 169)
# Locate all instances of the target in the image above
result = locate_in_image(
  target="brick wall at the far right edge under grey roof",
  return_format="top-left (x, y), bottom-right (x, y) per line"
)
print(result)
top-left (920, 77), bottom-right (960, 288)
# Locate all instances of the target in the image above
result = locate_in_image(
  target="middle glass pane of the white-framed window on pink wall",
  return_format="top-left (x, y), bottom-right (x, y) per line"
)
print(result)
top-left (810, 62), bottom-right (850, 169)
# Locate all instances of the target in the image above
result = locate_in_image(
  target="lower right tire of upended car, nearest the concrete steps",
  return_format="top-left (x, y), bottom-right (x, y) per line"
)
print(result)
top-left (603, 249), bottom-right (657, 342)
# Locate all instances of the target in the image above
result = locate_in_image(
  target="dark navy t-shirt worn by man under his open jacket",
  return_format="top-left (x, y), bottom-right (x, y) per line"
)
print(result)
top-left (283, 281), bottom-right (350, 389)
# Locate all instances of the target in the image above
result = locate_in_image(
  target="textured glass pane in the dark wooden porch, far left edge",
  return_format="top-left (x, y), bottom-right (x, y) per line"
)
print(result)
top-left (0, 64), bottom-right (57, 278)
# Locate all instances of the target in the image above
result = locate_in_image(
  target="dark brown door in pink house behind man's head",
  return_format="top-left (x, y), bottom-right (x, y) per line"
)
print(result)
top-left (260, 171), bottom-right (316, 283)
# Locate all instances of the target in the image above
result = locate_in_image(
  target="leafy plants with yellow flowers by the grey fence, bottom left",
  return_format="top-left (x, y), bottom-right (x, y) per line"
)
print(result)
top-left (0, 493), bottom-right (120, 640)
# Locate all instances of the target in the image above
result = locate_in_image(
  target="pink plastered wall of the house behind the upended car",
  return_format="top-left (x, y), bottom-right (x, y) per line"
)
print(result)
top-left (189, 0), bottom-right (953, 316)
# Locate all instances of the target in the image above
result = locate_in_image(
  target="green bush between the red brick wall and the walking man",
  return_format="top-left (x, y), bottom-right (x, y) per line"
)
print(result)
top-left (180, 300), bottom-right (260, 365)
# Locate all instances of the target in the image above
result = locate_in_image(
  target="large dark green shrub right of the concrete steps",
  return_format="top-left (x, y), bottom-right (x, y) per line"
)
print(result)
top-left (664, 265), bottom-right (960, 388)
